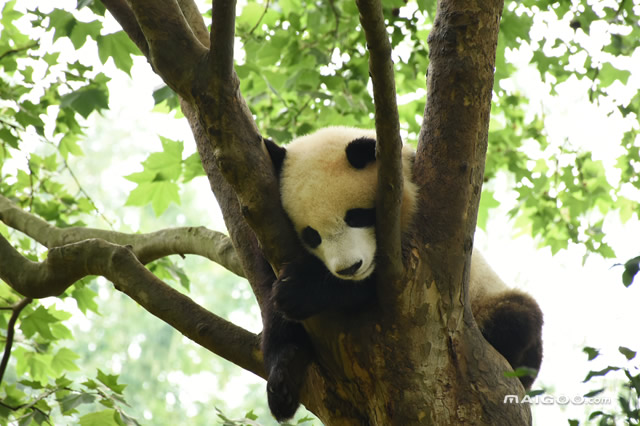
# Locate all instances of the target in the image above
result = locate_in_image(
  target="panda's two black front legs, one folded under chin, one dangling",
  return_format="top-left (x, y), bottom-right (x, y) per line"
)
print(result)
top-left (262, 252), bottom-right (375, 421)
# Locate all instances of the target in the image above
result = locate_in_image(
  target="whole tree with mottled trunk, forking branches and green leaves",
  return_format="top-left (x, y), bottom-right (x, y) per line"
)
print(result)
top-left (0, 0), bottom-right (640, 424)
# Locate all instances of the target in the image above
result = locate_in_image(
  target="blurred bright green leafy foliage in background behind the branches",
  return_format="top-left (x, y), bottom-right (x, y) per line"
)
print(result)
top-left (0, 0), bottom-right (640, 425)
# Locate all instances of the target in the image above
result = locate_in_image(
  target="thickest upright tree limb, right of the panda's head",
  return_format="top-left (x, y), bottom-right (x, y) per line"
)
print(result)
top-left (415, 0), bottom-right (503, 304)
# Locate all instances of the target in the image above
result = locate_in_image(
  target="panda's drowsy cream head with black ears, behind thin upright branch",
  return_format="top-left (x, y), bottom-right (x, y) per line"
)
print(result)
top-left (265, 127), bottom-right (415, 281)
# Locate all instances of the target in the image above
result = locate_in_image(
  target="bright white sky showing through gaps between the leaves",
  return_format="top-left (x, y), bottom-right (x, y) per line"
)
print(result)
top-left (5, 0), bottom-right (640, 426)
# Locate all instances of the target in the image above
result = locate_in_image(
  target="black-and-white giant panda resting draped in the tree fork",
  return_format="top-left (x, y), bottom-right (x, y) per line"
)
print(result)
top-left (262, 127), bottom-right (542, 421)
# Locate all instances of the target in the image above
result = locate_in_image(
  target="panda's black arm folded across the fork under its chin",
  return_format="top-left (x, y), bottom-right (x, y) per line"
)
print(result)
top-left (272, 254), bottom-right (375, 320)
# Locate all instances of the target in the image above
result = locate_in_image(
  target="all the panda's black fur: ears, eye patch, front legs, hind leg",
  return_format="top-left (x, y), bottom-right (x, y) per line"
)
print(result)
top-left (262, 138), bottom-right (542, 421)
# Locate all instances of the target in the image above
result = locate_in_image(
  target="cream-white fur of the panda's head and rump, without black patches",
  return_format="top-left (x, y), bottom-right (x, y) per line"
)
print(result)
top-left (280, 127), bottom-right (507, 302)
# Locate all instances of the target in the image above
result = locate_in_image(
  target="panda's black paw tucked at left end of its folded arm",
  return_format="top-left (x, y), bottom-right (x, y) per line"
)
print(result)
top-left (271, 275), bottom-right (319, 321)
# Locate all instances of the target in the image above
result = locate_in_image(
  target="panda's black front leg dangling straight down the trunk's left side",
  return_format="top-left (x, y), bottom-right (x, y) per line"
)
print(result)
top-left (262, 304), bottom-right (313, 422)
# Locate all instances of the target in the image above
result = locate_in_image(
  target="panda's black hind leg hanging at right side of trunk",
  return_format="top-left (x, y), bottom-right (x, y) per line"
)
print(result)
top-left (473, 290), bottom-right (543, 389)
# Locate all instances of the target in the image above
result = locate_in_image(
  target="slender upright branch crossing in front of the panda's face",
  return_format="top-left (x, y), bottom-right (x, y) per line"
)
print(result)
top-left (356, 0), bottom-right (403, 287)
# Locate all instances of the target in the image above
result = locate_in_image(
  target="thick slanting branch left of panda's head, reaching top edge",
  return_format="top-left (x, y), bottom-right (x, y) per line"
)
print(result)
top-left (189, 0), bottom-right (299, 269)
